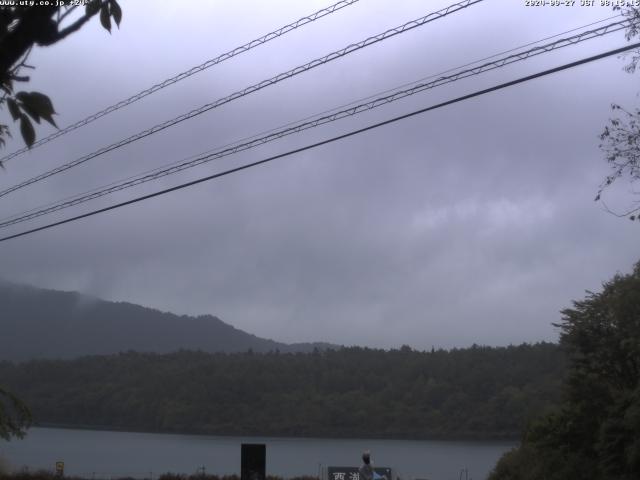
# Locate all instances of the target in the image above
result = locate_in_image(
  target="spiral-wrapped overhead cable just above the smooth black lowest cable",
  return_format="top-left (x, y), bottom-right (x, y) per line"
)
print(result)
top-left (0, 20), bottom-right (627, 228)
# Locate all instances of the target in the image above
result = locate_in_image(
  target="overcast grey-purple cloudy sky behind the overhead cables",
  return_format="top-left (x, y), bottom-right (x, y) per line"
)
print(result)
top-left (0, 0), bottom-right (640, 349)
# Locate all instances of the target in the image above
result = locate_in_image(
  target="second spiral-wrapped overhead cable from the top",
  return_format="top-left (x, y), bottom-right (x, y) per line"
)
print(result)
top-left (0, 0), bottom-right (484, 197)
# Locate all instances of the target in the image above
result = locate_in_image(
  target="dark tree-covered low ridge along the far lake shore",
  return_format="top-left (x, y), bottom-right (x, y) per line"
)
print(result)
top-left (0, 343), bottom-right (565, 438)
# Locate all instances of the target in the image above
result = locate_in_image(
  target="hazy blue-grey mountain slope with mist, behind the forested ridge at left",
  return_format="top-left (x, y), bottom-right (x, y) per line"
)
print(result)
top-left (0, 282), bottom-right (338, 361)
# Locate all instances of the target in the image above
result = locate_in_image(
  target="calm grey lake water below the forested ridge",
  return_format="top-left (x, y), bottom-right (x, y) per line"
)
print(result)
top-left (0, 428), bottom-right (515, 480)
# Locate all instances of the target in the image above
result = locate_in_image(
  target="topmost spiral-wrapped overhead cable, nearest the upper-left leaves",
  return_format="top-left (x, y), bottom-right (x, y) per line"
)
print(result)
top-left (0, 0), bottom-right (359, 164)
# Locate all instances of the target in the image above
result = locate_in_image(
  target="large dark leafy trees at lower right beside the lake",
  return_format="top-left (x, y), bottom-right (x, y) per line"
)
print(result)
top-left (491, 262), bottom-right (640, 480)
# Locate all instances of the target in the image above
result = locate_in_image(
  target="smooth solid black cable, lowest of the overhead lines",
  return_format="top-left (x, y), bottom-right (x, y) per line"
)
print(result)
top-left (0, 42), bottom-right (640, 242)
